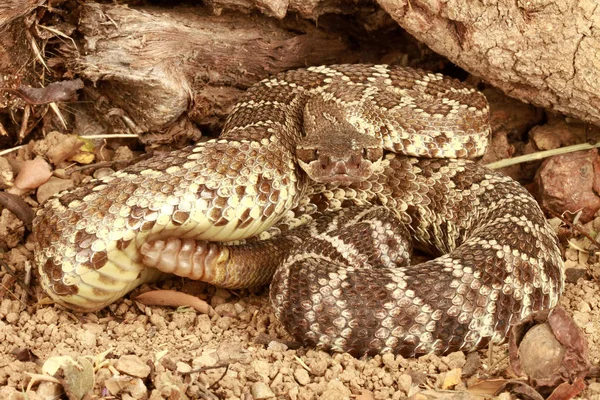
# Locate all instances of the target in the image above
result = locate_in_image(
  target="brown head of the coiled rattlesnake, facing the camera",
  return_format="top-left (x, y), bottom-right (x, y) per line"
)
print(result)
top-left (296, 131), bottom-right (383, 184)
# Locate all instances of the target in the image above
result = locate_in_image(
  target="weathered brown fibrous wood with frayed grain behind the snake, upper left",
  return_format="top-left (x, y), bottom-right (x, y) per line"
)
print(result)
top-left (66, 3), bottom-right (370, 139)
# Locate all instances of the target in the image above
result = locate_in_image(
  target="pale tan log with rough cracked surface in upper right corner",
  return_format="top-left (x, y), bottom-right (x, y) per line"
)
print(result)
top-left (377, 0), bottom-right (600, 125)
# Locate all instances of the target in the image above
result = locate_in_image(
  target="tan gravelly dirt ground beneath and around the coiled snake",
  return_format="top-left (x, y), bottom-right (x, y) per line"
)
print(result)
top-left (0, 160), bottom-right (600, 400)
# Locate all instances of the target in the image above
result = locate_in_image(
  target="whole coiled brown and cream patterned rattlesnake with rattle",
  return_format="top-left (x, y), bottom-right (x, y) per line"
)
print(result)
top-left (33, 64), bottom-right (563, 356)
